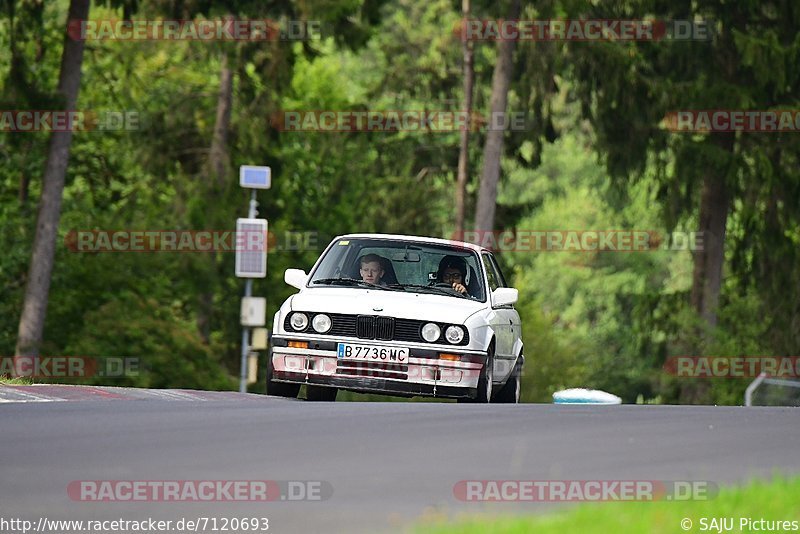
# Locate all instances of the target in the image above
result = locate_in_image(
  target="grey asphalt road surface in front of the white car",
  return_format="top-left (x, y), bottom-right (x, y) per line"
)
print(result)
top-left (0, 394), bottom-right (800, 533)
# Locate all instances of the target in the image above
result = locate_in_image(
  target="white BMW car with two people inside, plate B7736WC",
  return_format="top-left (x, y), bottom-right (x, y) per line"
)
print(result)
top-left (267, 234), bottom-right (525, 403)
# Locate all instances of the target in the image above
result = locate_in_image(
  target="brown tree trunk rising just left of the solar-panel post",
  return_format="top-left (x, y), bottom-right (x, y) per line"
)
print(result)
top-left (197, 51), bottom-right (233, 344)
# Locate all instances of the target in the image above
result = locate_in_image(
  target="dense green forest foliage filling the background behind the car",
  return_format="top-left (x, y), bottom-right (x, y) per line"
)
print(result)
top-left (0, 0), bottom-right (800, 403)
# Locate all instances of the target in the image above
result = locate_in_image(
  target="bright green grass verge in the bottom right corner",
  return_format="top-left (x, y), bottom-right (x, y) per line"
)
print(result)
top-left (414, 476), bottom-right (800, 534)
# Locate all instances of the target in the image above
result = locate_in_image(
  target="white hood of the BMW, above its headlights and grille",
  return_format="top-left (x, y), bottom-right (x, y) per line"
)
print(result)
top-left (291, 287), bottom-right (487, 324)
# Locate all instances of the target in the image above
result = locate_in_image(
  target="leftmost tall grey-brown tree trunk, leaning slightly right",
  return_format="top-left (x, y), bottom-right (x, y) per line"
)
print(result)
top-left (15, 0), bottom-right (89, 362)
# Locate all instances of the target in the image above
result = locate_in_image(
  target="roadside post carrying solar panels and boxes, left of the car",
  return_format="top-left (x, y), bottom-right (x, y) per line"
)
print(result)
top-left (236, 165), bottom-right (272, 393)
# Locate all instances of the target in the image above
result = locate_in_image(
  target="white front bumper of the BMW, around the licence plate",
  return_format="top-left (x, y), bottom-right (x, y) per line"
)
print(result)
top-left (270, 335), bottom-right (486, 398)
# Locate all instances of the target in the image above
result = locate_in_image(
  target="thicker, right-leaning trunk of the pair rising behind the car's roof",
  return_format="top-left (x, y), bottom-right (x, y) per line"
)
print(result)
top-left (475, 0), bottom-right (520, 230)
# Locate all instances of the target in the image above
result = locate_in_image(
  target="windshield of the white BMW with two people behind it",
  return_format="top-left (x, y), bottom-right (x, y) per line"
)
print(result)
top-left (309, 238), bottom-right (486, 301)
